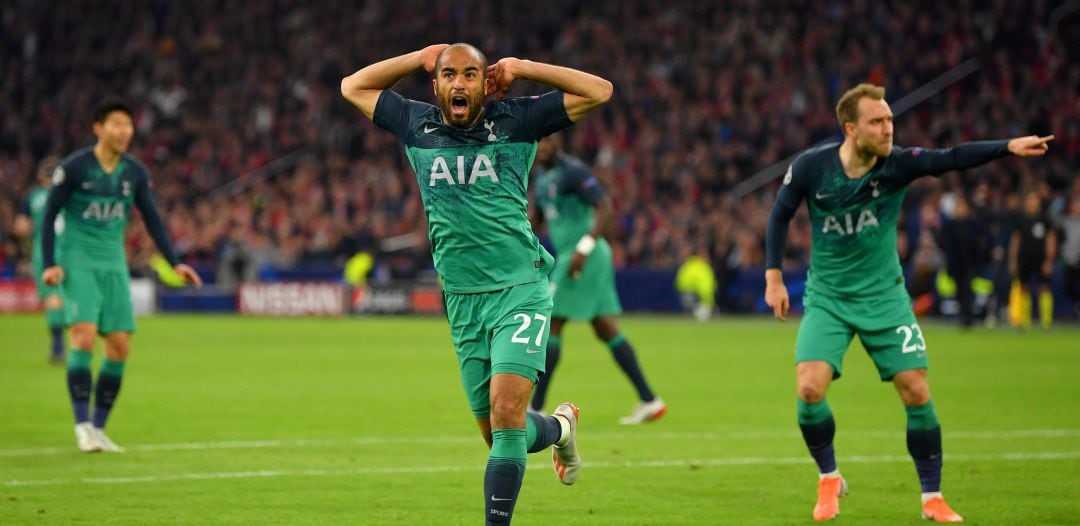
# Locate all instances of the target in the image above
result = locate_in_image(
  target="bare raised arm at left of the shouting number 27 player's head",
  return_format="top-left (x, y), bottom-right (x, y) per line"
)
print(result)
top-left (341, 44), bottom-right (449, 119)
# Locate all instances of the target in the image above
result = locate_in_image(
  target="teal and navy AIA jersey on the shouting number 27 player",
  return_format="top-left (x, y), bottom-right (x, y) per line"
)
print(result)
top-left (374, 90), bottom-right (571, 293)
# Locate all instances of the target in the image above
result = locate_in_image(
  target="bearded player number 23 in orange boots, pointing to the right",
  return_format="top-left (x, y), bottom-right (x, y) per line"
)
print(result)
top-left (765, 84), bottom-right (1053, 523)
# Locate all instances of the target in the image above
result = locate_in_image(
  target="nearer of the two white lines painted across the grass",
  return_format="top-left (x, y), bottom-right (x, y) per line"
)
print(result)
top-left (3, 451), bottom-right (1080, 487)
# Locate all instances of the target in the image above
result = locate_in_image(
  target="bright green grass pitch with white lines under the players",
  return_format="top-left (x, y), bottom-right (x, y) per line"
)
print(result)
top-left (0, 315), bottom-right (1080, 525)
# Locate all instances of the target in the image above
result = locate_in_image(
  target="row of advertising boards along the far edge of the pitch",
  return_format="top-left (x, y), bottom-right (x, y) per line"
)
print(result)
top-left (0, 267), bottom-right (1077, 319)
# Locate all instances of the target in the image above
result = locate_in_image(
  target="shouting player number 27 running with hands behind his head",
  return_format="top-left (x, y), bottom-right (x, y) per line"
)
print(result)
top-left (341, 43), bottom-right (611, 524)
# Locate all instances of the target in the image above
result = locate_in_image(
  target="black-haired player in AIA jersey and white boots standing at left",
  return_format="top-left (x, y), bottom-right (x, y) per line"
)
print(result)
top-left (41, 102), bottom-right (202, 453)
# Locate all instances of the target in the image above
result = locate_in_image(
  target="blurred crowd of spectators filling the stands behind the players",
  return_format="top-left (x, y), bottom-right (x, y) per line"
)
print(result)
top-left (0, 0), bottom-right (1080, 308)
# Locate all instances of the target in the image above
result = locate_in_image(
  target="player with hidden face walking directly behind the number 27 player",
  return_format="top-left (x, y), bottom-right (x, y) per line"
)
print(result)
top-left (530, 134), bottom-right (667, 424)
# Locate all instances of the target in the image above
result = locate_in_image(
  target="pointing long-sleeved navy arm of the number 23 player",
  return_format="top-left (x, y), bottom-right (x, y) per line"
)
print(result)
top-left (901, 135), bottom-right (1054, 177)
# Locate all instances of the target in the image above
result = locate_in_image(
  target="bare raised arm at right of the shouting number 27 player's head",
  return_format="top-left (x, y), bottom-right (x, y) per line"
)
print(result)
top-left (487, 56), bottom-right (613, 122)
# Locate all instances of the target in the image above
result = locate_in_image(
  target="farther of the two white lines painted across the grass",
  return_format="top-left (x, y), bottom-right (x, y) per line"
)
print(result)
top-left (0, 429), bottom-right (1080, 457)
